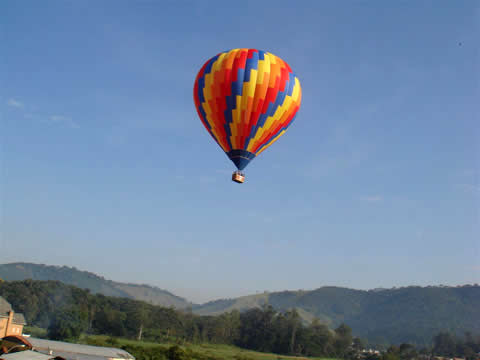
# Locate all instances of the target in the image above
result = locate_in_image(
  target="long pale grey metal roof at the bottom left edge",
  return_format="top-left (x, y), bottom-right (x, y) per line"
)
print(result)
top-left (28, 337), bottom-right (135, 360)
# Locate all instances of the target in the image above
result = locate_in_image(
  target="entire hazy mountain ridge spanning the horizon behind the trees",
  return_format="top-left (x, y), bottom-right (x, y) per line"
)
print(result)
top-left (0, 263), bottom-right (480, 344)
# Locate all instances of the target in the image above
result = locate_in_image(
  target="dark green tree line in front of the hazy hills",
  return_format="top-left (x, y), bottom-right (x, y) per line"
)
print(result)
top-left (0, 280), bottom-right (480, 360)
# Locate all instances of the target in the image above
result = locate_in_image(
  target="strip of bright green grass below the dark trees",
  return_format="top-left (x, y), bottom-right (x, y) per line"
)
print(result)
top-left (81, 335), bottom-right (338, 360)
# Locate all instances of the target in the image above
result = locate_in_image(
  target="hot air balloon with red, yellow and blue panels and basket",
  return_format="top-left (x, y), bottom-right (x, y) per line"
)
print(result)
top-left (193, 49), bottom-right (302, 183)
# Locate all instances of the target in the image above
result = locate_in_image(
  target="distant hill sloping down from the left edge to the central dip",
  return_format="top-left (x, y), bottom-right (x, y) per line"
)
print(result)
top-left (0, 263), bottom-right (191, 309)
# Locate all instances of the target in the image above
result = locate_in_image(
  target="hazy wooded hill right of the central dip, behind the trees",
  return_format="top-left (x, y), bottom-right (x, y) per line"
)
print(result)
top-left (193, 285), bottom-right (480, 345)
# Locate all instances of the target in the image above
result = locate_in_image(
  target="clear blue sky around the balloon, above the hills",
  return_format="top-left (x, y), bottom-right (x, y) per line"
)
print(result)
top-left (0, 0), bottom-right (480, 302)
